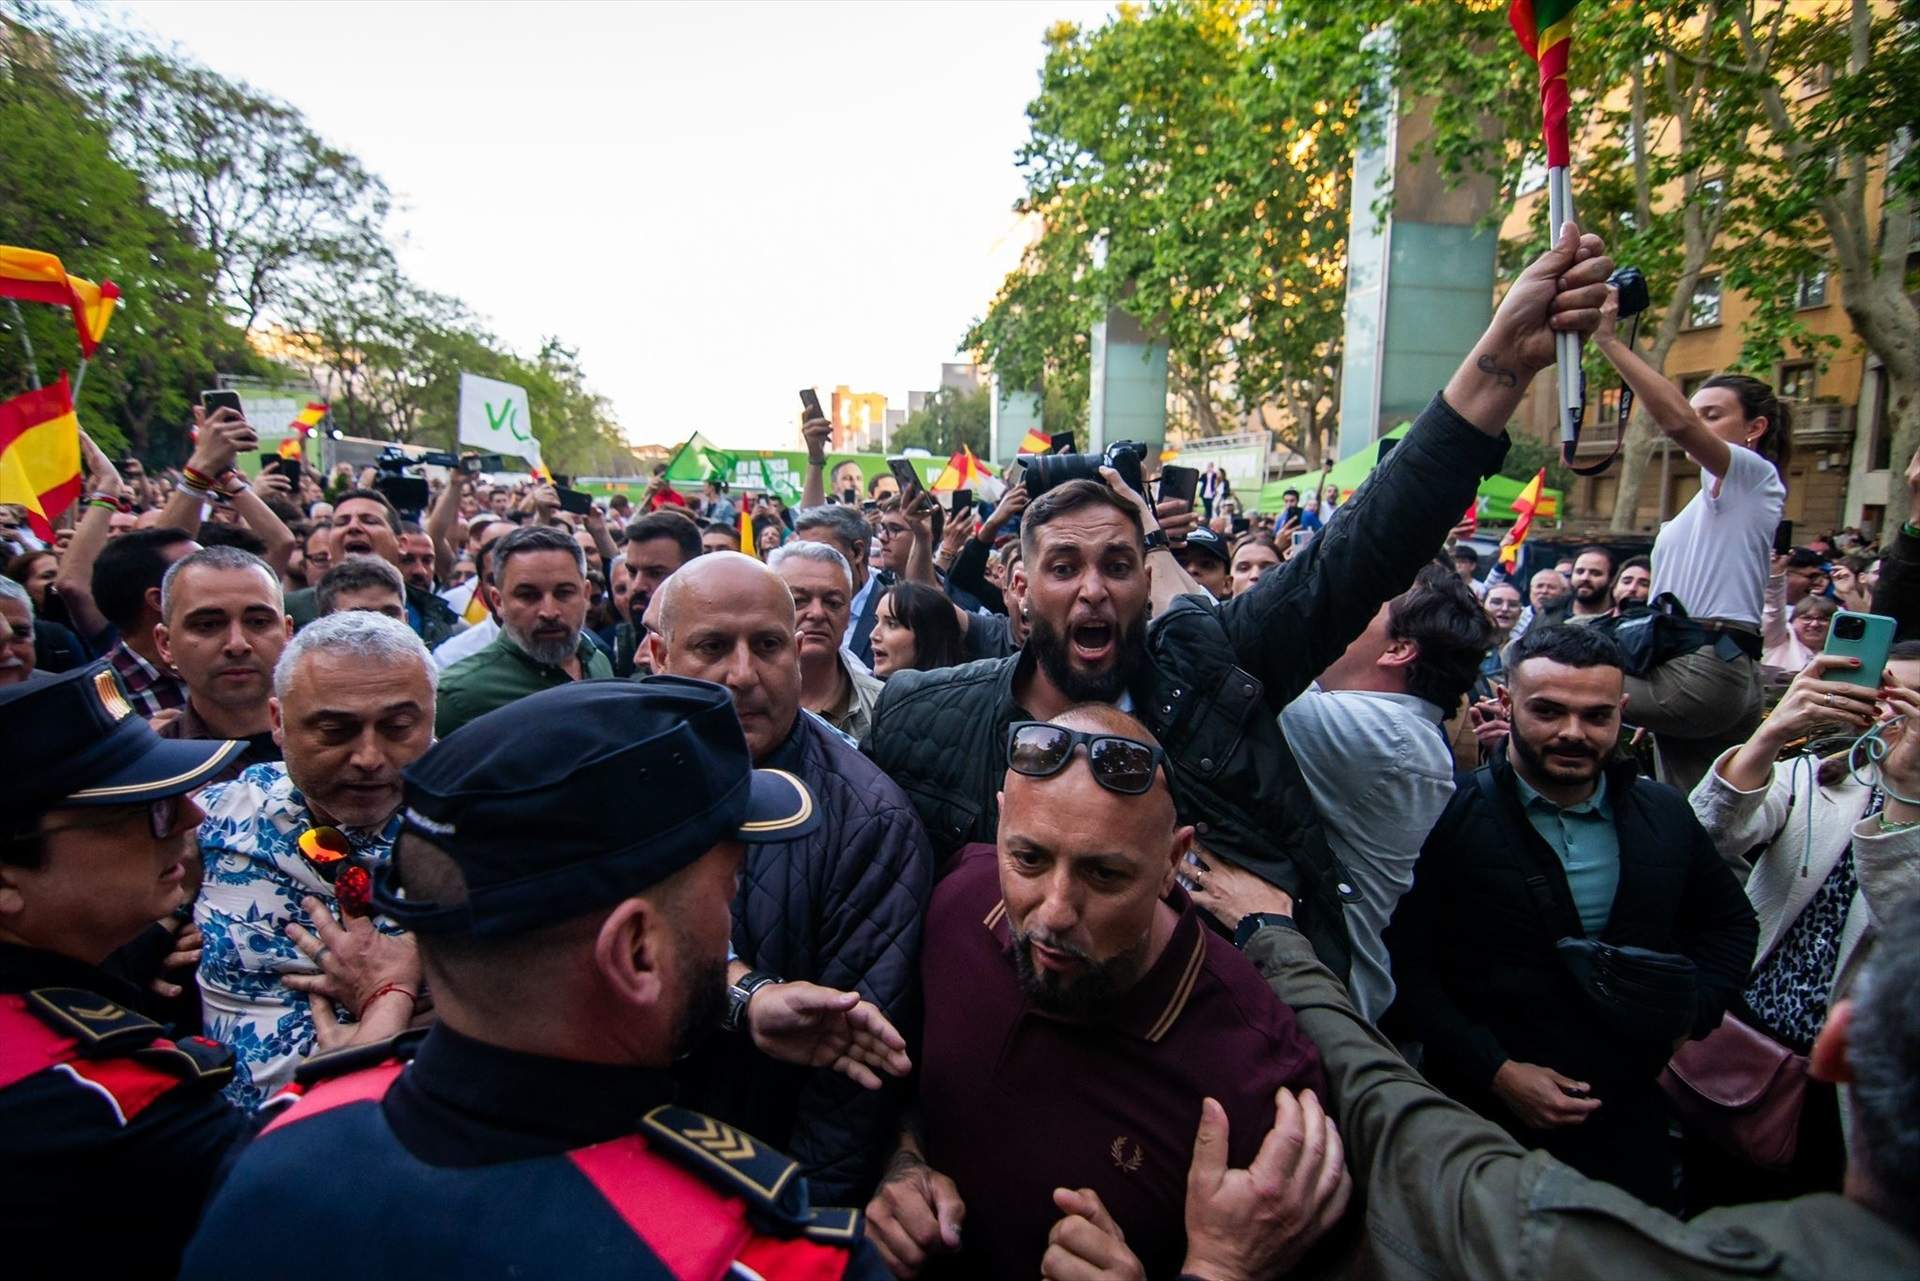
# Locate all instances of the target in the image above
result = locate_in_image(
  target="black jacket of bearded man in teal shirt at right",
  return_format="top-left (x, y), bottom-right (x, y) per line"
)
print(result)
top-left (1386, 755), bottom-right (1759, 1108)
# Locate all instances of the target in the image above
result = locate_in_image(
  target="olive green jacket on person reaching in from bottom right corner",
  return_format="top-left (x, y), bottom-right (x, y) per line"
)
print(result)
top-left (1246, 926), bottom-right (1920, 1281)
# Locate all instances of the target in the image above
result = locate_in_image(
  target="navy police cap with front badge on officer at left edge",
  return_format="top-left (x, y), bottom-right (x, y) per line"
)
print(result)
top-left (0, 663), bottom-right (246, 832)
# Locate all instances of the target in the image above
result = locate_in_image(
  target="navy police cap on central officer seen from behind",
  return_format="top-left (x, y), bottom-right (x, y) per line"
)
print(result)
top-left (374, 676), bottom-right (818, 937)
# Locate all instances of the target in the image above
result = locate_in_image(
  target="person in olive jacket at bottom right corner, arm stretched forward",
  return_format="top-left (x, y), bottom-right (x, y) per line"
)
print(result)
top-left (1194, 864), bottom-right (1920, 1281)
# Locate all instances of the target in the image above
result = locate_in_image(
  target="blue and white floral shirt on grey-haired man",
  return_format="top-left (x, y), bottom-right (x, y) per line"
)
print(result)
top-left (194, 762), bottom-right (399, 1108)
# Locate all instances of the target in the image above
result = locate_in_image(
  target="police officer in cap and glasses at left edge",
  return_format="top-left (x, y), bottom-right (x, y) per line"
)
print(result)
top-left (0, 663), bottom-right (246, 1277)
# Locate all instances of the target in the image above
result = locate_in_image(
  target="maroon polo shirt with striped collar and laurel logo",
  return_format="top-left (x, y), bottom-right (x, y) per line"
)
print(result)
top-left (920, 845), bottom-right (1327, 1277)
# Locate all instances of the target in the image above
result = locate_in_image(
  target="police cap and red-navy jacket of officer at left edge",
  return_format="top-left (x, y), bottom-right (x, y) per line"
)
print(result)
top-left (0, 665), bottom-right (248, 1277)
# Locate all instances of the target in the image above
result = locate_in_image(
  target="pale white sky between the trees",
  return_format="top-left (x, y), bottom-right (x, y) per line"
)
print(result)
top-left (125, 0), bottom-right (1108, 447)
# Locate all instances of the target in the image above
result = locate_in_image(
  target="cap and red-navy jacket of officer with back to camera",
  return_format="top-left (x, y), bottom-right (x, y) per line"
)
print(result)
top-left (182, 676), bottom-right (887, 1281)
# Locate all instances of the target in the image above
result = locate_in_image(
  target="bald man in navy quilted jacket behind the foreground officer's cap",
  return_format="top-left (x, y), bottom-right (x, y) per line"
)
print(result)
top-left (647, 551), bottom-right (933, 1206)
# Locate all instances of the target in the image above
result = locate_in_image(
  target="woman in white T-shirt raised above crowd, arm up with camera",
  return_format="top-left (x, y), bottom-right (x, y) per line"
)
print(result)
top-left (1594, 288), bottom-right (1791, 791)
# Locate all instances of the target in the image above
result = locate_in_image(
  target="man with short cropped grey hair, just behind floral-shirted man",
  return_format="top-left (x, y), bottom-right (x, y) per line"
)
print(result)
top-left (154, 547), bottom-right (294, 782)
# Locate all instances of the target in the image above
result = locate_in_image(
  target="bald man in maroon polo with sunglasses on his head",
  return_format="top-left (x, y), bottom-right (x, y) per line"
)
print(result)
top-left (868, 705), bottom-right (1338, 1277)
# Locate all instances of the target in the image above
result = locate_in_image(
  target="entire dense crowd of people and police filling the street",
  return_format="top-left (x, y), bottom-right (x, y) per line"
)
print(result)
top-left (0, 229), bottom-right (1920, 1281)
